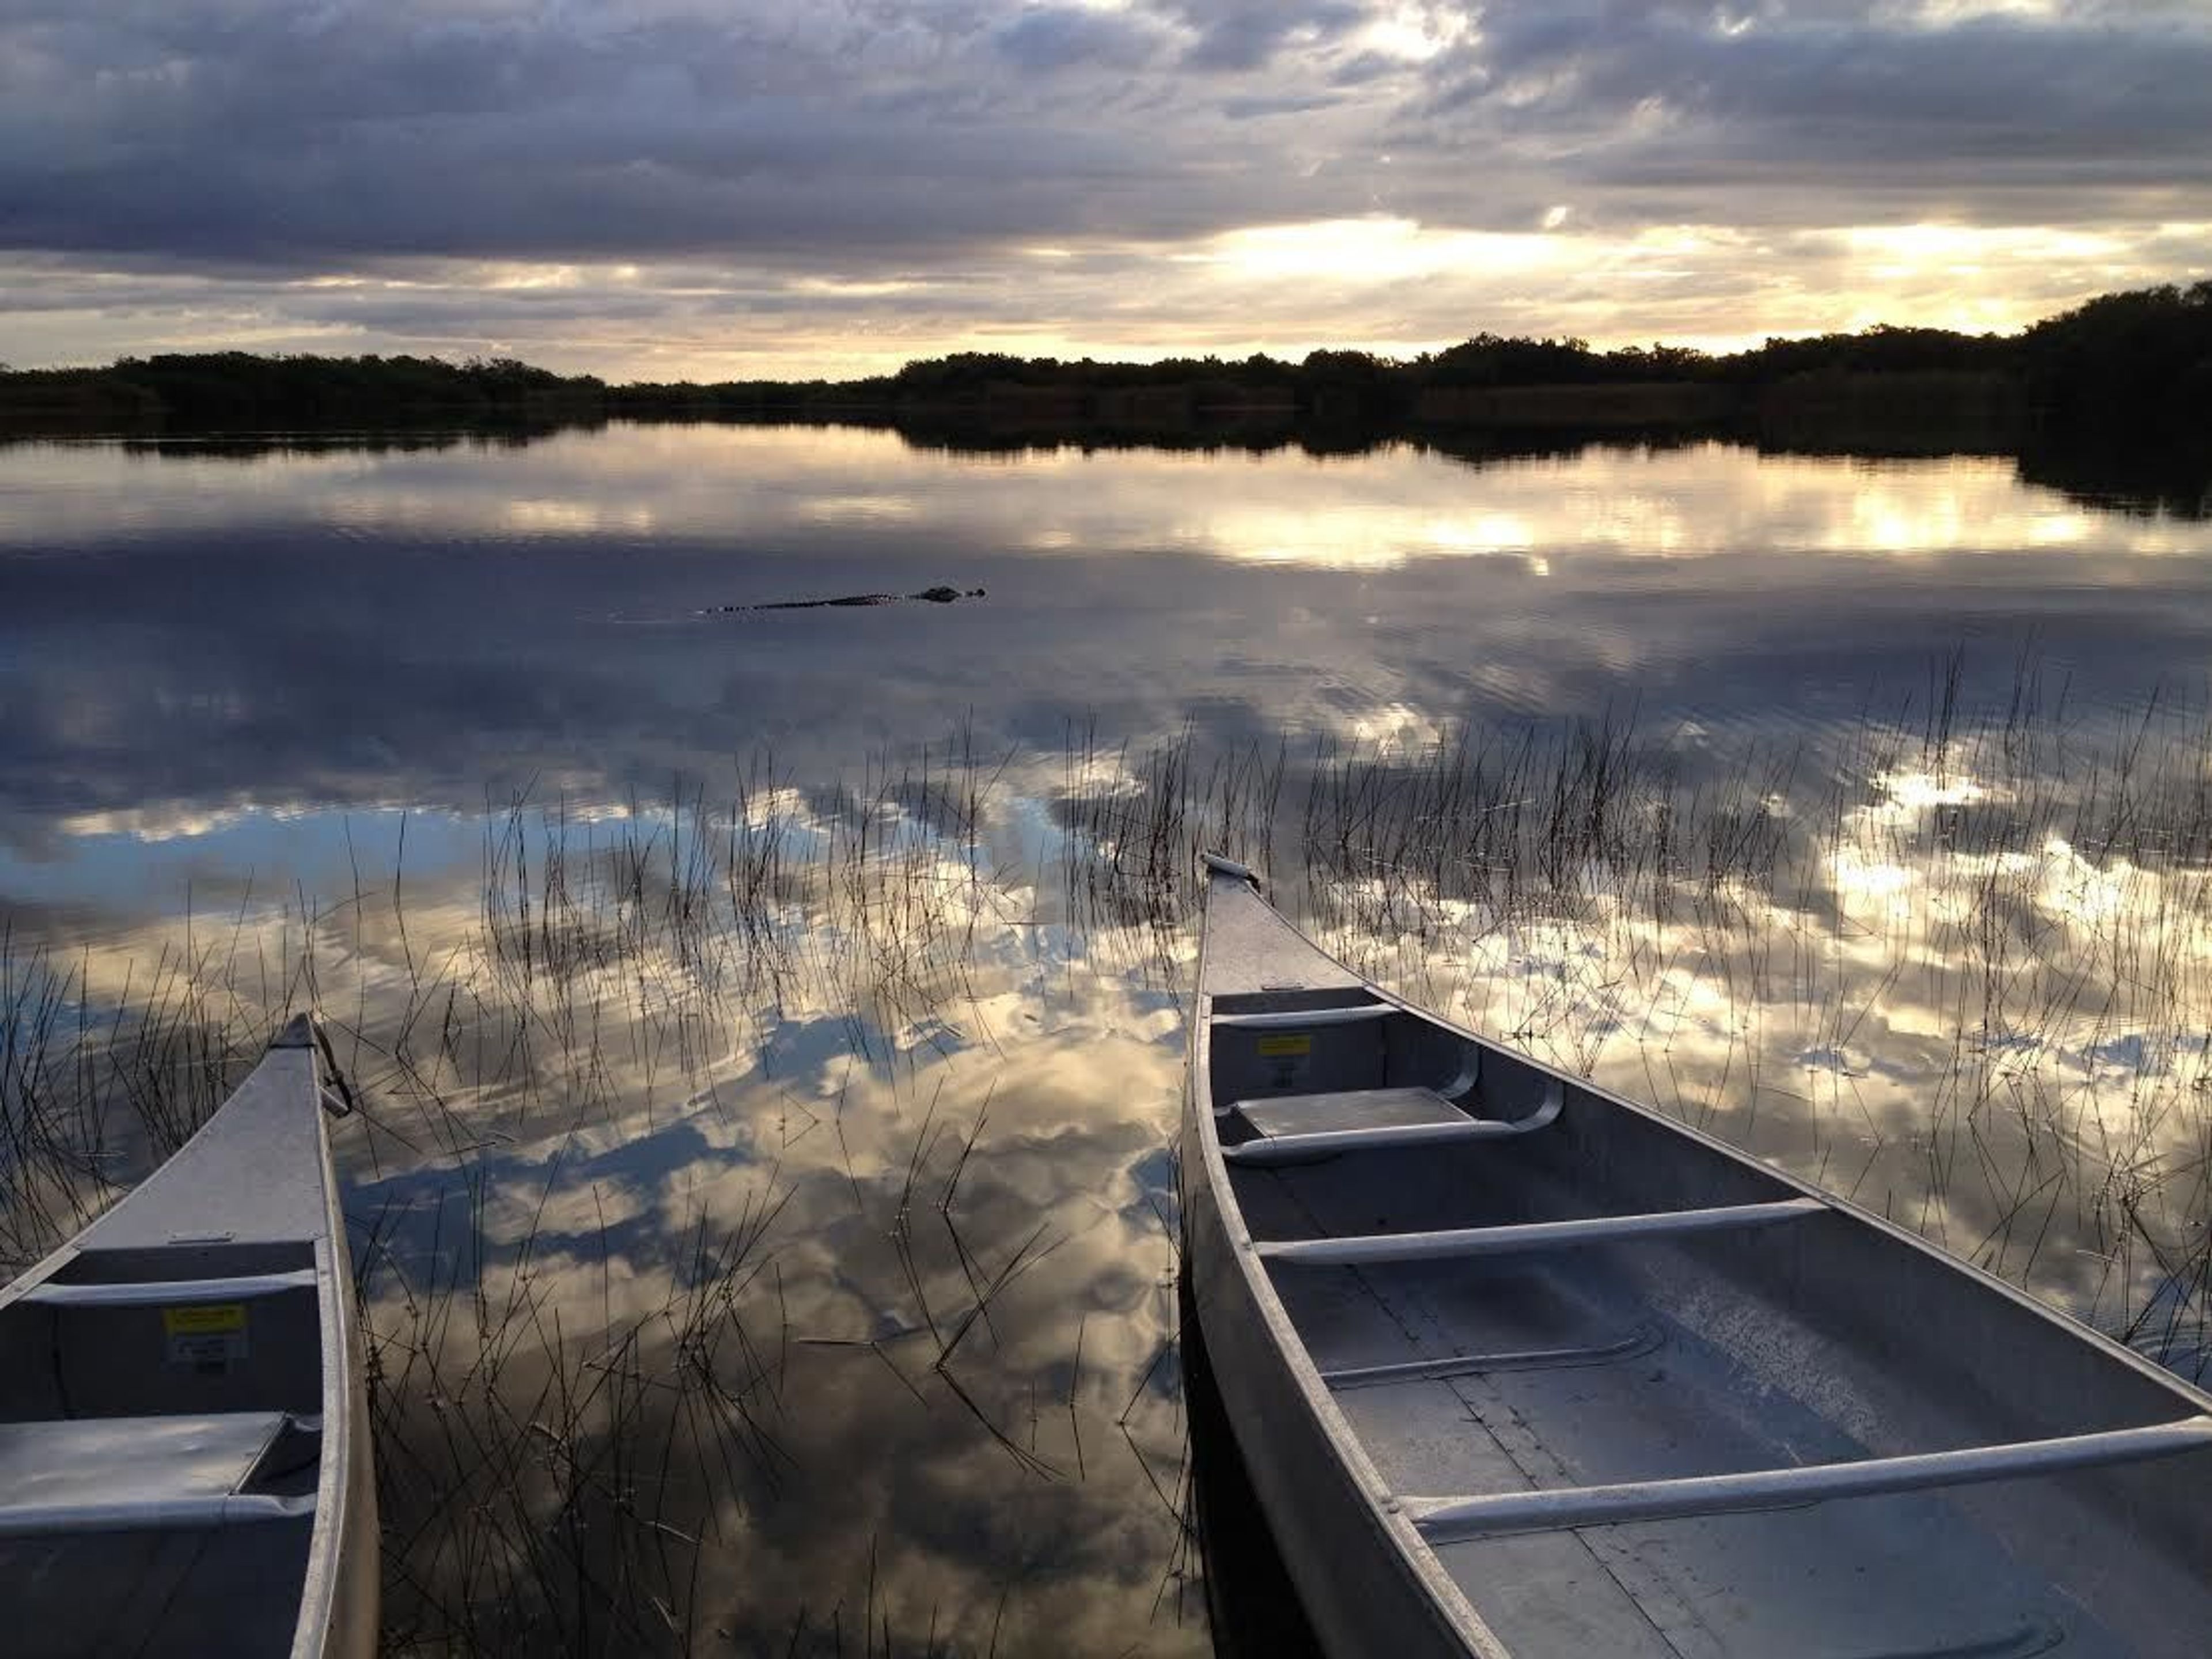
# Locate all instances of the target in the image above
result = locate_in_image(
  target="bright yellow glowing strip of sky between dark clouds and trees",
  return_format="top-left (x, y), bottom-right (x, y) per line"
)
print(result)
top-left (90, 214), bottom-right (2176, 380)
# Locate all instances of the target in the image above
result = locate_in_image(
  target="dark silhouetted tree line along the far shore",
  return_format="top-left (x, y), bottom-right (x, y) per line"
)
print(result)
top-left (0, 283), bottom-right (2212, 435)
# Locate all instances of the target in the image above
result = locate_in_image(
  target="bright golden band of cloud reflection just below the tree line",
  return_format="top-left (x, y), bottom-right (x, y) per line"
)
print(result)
top-left (13, 425), bottom-right (2212, 569)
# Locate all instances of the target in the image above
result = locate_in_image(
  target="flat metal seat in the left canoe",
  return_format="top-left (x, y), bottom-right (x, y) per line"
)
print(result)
top-left (0, 1411), bottom-right (319, 1537)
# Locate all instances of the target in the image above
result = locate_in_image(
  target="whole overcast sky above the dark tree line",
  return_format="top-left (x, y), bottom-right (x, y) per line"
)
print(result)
top-left (0, 0), bottom-right (2212, 378)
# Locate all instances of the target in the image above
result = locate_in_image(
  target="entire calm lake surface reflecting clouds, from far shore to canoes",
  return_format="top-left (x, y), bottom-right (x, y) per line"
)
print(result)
top-left (0, 427), bottom-right (2212, 1654)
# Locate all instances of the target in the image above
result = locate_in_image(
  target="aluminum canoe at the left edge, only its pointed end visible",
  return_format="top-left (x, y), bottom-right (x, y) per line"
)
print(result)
top-left (0, 1016), bottom-right (376, 1659)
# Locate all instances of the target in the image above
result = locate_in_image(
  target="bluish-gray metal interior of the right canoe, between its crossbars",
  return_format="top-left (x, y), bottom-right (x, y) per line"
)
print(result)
top-left (1199, 982), bottom-right (2212, 1659)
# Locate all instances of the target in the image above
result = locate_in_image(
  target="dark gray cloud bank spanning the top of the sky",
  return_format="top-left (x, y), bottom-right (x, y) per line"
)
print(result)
top-left (0, 0), bottom-right (2212, 263)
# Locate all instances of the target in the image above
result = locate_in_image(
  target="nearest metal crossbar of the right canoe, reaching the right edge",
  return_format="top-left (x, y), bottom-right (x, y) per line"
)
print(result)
top-left (1403, 1416), bottom-right (2212, 1544)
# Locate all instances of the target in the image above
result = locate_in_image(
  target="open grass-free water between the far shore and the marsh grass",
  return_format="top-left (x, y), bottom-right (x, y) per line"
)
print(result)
top-left (13, 427), bottom-right (2212, 889)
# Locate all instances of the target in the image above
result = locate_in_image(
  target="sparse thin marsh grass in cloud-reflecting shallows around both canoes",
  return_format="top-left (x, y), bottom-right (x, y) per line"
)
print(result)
top-left (0, 659), bottom-right (2212, 1654)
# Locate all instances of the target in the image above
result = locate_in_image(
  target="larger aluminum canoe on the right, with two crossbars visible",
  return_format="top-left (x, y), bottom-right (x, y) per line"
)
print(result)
top-left (1183, 858), bottom-right (2212, 1659)
